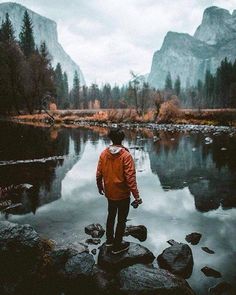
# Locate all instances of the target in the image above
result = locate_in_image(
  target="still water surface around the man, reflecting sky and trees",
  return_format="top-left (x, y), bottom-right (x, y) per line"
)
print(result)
top-left (0, 123), bottom-right (236, 294)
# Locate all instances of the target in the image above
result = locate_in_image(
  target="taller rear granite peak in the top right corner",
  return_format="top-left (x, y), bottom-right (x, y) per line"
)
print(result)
top-left (194, 6), bottom-right (236, 45)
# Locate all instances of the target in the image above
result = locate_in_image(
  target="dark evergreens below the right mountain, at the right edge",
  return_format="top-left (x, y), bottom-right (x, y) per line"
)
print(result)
top-left (165, 58), bottom-right (236, 109)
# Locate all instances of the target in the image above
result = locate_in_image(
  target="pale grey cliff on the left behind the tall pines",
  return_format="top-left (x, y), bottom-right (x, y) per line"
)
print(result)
top-left (0, 2), bottom-right (85, 86)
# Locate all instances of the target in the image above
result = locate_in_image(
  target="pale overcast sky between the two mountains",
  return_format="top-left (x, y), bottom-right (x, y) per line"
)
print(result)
top-left (0, 0), bottom-right (236, 84)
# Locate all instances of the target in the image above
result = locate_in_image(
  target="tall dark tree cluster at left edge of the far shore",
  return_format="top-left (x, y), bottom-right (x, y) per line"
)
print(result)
top-left (0, 11), bottom-right (54, 114)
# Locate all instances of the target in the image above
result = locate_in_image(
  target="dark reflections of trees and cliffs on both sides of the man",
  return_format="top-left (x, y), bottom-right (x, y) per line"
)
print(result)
top-left (0, 123), bottom-right (236, 213)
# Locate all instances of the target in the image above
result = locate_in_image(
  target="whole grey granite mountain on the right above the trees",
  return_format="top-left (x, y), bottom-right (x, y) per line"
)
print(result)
top-left (148, 6), bottom-right (236, 88)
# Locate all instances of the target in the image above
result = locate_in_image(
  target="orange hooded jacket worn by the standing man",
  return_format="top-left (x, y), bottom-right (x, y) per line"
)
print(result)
top-left (96, 146), bottom-right (139, 200)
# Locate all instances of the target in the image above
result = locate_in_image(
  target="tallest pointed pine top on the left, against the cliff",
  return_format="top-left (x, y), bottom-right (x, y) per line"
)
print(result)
top-left (19, 10), bottom-right (35, 58)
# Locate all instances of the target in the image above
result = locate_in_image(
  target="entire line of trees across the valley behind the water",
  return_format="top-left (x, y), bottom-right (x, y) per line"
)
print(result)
top-left (0, 11), bottom-right (236, 115)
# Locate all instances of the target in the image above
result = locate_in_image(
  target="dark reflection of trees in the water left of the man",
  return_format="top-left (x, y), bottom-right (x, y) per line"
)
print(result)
top-left (0, 125), bottom-right (87, 214)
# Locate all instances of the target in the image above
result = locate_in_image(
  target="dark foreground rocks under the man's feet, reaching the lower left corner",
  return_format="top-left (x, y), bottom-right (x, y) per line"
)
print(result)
top-left (0, 221), bottom-right (197, 295)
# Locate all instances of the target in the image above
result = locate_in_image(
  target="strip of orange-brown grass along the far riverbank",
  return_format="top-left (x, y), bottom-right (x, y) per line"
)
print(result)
top-left (4, 109), bottom-right (236, 127)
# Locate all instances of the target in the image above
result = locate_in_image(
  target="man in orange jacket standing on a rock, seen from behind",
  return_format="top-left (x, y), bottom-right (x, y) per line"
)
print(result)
top-left (96, 128), bottom-right (142, 254)
